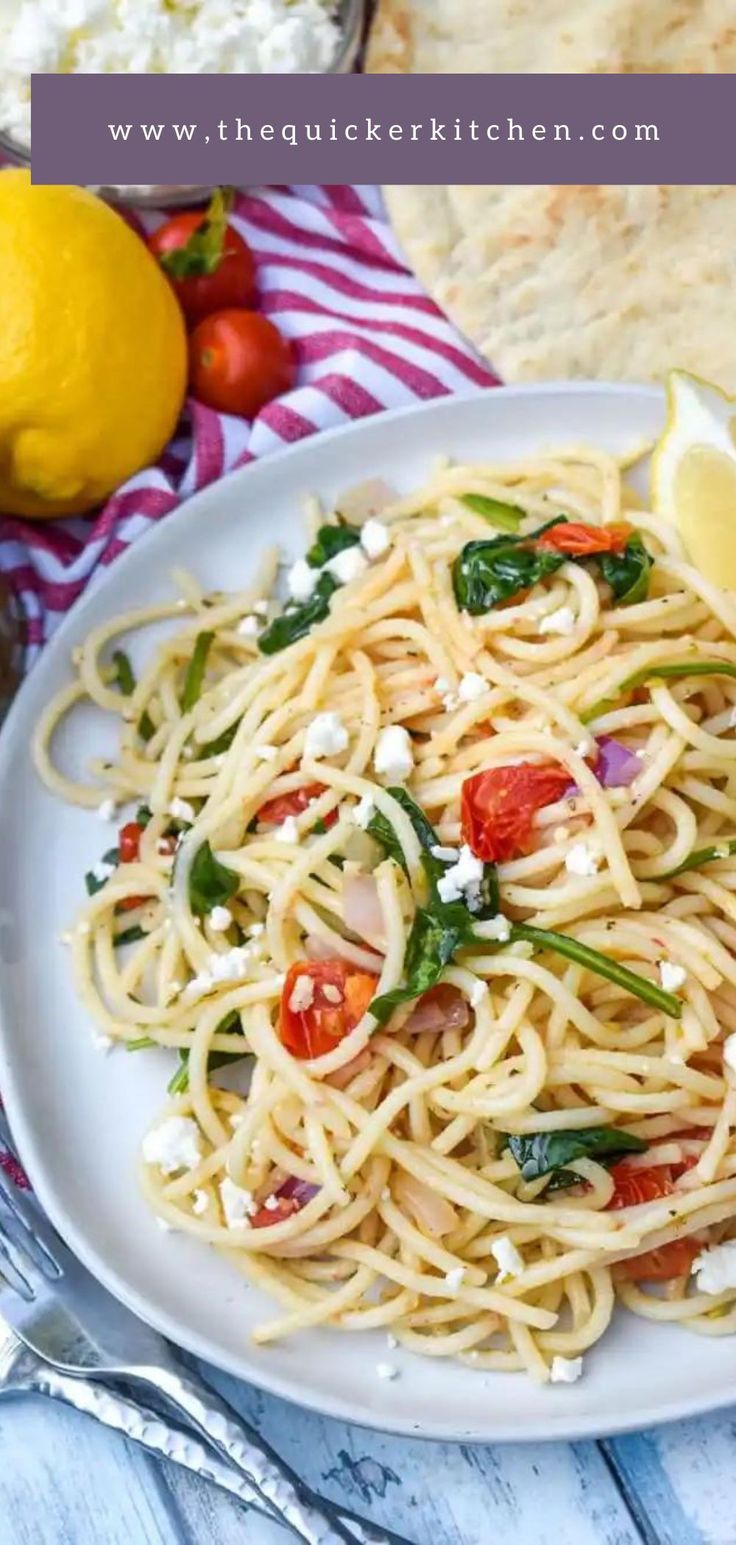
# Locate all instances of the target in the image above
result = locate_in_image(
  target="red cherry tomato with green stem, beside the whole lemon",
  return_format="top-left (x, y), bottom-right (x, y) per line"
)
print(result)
top-left (148, 190), bottom-right (255, 328)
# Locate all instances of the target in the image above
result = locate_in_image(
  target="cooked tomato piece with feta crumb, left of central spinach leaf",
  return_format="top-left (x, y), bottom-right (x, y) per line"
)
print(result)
top-left (278, 959), bottom-right (377, 1058)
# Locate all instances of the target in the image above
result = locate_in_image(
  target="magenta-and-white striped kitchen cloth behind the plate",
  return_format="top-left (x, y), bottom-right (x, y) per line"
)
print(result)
top-left (0, 187), bottom-right (496, 664)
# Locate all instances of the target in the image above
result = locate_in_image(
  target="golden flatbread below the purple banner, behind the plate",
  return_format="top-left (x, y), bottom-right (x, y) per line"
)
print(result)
top-left (385, 185), bottom-right (736, 392)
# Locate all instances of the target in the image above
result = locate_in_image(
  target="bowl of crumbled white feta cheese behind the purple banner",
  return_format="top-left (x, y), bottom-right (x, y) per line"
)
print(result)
top-left (0, 0), bottom-right (365, 204)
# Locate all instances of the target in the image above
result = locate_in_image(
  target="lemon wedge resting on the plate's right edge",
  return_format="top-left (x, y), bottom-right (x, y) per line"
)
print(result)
top-left (653, 371), bottom-right (736, 590)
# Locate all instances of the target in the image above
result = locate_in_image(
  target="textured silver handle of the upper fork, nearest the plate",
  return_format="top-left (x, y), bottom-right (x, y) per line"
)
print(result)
top-left (125, 1364), bottom-right (411, 1545)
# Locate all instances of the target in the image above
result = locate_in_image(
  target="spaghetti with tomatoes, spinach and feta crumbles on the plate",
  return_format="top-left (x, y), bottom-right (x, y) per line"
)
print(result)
top-left (34, 448), bottom-right (736, 1381)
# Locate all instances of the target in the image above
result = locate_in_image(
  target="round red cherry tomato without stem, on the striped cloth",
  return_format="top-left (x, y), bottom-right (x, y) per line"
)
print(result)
top-left (189, 309), bottom-right (297, 419)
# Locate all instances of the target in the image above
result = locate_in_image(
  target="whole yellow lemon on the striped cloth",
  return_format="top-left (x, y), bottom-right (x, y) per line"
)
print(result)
top-left (0, 171), bottom-right (187, 519)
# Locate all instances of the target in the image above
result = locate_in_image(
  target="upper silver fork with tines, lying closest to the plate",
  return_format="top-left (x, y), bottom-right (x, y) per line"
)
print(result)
top-left (0, 1111), bottom-right (408, 1545)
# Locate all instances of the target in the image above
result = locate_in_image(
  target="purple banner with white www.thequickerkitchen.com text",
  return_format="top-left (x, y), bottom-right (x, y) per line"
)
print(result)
top-left (32, 76), bottom-right (736, 184)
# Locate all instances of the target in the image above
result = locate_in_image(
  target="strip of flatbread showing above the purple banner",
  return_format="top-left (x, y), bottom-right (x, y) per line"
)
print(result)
top-left (365, 0), bottom-right (736, 74)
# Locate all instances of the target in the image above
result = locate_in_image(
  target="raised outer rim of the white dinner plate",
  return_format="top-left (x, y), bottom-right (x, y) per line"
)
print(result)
top-left (0, 380), bottom-right (734, 1443)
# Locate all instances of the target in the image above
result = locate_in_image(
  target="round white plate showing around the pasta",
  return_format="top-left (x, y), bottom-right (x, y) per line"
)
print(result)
top-left (0, 385), bottom-right (736, 1441)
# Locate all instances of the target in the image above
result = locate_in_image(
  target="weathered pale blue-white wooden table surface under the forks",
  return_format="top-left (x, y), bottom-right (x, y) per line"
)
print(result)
top-left (0, 1369), bottom-right (736, 1545)
